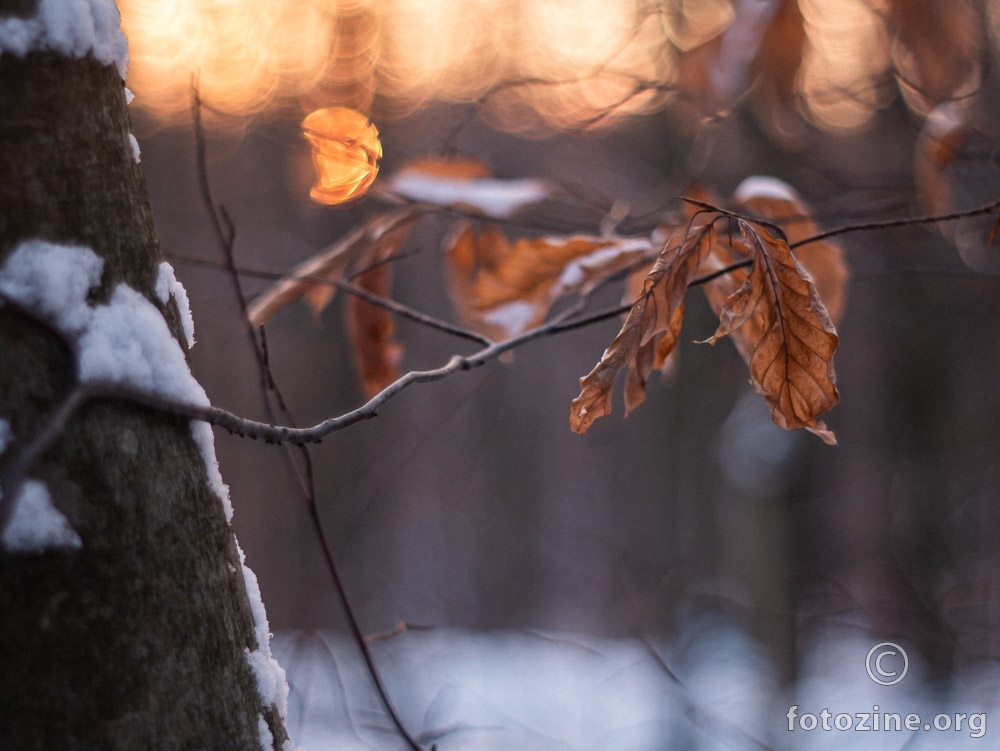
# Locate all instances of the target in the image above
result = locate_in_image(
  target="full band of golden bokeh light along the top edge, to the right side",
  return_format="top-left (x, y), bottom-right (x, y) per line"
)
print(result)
top-left (119, 0), bottom-right (984, 135)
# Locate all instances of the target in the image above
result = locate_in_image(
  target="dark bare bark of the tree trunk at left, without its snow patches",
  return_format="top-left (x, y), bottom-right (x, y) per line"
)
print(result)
top-left (0, 7), bottom-right (287, 751)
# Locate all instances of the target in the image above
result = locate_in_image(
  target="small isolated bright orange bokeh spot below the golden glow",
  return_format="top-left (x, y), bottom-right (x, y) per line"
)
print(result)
top-left (302, 107), bottom-right (382, 205)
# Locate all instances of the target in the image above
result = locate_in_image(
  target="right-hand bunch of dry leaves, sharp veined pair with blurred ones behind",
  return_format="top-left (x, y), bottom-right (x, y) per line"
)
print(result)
top-left (570, 178), bottom-right (847, 443)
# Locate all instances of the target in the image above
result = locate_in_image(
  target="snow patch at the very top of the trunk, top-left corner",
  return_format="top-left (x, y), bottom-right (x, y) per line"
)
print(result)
top-left (0, 0), bottom-right (128, 79)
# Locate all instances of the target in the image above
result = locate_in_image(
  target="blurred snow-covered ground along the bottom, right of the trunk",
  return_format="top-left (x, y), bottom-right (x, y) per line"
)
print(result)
top-left (273, 622), bottom-right (1000, 751)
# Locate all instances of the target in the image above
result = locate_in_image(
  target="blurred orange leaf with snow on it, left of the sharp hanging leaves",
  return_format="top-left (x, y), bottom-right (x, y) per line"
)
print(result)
top-left (445, 223), bottom-right (653, 341)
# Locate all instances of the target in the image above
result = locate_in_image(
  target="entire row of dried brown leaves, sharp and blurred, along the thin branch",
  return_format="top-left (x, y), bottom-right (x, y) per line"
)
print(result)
top-left (251, 161), bottom-right (848, 443)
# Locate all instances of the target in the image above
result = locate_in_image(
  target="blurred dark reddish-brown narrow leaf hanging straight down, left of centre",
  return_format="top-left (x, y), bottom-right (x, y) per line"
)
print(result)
top-left (344, 263), bottom-right (403, 398)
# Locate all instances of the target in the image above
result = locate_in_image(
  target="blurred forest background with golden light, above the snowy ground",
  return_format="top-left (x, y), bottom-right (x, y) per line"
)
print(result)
top-left (119, 0), bottom-right (1000, 724)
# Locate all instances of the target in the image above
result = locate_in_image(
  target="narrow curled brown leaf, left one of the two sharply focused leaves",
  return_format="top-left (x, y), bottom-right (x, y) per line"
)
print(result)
top-left (569, 218), bottom-right (712, 433)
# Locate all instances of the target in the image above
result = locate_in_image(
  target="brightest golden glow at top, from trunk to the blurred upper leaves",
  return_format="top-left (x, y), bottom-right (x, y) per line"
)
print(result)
top-left (119, 0), bottom-right (688, 132)
